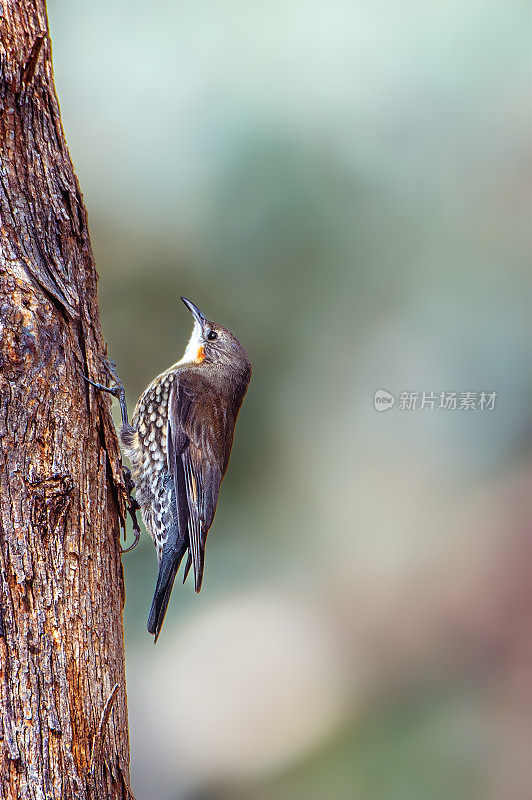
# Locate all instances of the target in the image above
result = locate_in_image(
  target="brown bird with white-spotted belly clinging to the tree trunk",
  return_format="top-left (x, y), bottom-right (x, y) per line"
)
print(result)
top-left (84, 297), bottom-right (251, 643)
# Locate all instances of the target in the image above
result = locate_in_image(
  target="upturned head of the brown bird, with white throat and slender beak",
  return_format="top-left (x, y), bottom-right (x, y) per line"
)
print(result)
top-left (181, 297), bottom-right (251, 384)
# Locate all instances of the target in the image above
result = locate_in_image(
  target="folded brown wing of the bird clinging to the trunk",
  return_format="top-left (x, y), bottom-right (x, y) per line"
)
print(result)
top-left (167, 372), bottom-right (229, 592)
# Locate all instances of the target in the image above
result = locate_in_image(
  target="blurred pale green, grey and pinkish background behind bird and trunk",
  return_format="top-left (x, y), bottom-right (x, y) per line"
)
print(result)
top-left (48, 0), bottom-right (532, 800)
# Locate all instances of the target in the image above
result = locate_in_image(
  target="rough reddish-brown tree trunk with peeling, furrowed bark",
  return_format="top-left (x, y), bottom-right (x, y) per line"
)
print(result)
top-left (0, 0), bottom-right (131, 800)
